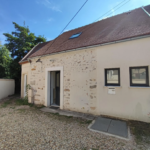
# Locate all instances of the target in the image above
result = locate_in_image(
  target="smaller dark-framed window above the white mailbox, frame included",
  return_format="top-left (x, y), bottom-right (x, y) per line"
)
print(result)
top-left (105, 68), bottom-right (120, 86)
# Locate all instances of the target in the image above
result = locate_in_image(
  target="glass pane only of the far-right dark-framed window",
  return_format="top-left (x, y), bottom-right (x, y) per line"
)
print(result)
top-left (132, 68), bottom-right (146, 84)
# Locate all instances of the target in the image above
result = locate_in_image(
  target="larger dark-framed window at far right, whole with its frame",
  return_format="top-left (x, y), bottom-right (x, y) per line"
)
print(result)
top-left (130, 67), bottom-right (149, 86)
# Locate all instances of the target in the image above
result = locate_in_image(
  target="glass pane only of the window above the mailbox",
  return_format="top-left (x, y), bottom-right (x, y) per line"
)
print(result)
top-left (107, 70), bottom-right (119, 84)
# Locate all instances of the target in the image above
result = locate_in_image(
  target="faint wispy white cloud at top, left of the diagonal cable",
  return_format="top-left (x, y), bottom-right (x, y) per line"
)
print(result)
top-left (36, 0), bottom-right (62, 12)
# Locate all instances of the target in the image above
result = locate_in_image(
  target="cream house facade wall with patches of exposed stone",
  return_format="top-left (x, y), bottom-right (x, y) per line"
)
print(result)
top-left (22, 38), bottom-right (150, 122)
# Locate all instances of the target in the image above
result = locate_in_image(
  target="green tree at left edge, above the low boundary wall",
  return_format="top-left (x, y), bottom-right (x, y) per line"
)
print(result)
top-left (0, 45), bottom-right (12, 78)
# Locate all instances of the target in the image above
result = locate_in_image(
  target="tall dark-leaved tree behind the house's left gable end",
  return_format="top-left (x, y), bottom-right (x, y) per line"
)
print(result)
top-left (3, 22), bottom-right (46, 92)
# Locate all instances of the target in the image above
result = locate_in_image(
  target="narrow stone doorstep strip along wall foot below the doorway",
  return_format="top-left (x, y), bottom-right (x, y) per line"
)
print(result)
top-left (40, 107), bottom-right (97, 120)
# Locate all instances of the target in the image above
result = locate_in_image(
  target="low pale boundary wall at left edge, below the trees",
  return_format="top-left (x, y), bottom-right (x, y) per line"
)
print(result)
top-left (0, 79), bottom-right (15, 100)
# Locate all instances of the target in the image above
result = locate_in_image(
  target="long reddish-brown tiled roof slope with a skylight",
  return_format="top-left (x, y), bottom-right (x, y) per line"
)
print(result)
top-left (21, 5), bottom-right (150, 61)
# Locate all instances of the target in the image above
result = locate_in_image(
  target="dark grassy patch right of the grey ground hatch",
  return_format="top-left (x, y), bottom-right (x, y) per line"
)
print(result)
top-left (129, 121), bottom-right (150, 144)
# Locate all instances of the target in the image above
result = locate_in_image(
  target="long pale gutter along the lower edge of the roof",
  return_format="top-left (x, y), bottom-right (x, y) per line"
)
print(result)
top-left (27, 35), bottom-right (150, 60)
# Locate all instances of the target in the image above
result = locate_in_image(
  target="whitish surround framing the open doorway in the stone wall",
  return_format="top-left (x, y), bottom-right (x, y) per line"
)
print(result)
top-left (45, 66), bottom-right (63, 109)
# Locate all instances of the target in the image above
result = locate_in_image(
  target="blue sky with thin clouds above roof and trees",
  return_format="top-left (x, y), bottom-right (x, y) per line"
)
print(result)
top-left (0, 0), bottom-right (150, 44)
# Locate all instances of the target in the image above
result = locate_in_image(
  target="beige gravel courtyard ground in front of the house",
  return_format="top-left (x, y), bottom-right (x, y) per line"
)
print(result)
top-left (0, 98), bottom-right (146, 150)
